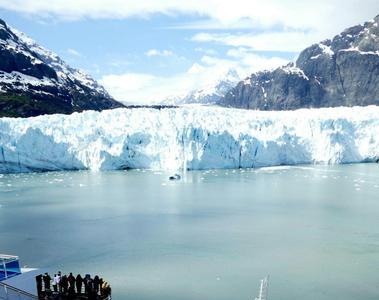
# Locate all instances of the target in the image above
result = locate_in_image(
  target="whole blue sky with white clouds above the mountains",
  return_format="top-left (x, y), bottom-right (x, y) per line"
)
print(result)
top-left (0, 0), bottom-right (379, 103)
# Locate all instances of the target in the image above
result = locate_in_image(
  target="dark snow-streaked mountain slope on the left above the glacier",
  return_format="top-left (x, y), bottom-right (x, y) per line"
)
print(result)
top-left (0, 20), bottom-right (122, 117)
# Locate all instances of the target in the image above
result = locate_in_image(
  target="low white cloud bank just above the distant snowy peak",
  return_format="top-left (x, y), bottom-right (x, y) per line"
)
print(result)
top-left (100, 49), bottom-right (287, 104)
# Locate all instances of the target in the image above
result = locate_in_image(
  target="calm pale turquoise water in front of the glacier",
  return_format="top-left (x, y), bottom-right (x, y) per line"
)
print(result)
top-left (0, 164), bottom-right (379, 300)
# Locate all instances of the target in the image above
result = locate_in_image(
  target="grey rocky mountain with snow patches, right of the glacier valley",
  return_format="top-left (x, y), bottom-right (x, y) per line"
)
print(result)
top-left (220, 15), bottom-right (379, 110)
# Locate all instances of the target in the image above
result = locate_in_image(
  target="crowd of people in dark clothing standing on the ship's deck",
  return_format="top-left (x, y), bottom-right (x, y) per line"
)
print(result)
top-left (36, 272), bottom-right (111, 300)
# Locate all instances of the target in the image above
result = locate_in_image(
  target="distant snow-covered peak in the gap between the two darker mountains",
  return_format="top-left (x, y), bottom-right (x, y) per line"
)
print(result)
top-left (162, 69), bottom-right (241, 105)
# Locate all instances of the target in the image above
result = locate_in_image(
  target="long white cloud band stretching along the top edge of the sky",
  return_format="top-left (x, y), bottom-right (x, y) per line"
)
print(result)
top-left (0, 0), bottom-right (379, 37)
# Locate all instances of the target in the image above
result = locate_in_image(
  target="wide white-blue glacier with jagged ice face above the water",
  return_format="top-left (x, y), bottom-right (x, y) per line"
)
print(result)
top-left (0, 106), bottom-right (379, 173)
